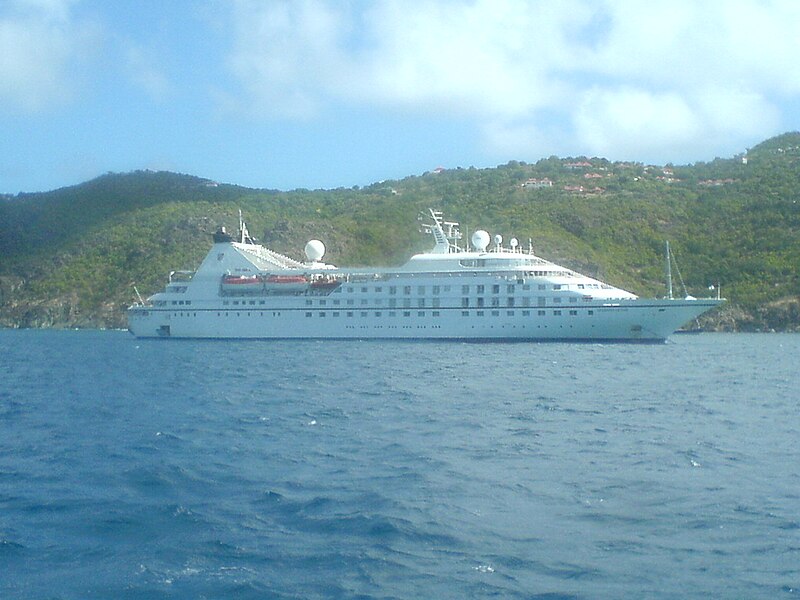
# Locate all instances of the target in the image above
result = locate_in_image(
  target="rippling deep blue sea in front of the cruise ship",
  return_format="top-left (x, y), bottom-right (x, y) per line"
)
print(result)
top-left (0, 330), bottom-right (800, 600)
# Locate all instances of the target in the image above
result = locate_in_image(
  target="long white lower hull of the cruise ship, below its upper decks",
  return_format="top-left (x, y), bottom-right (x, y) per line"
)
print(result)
top-left (129, 299), bottom-right (719, 342)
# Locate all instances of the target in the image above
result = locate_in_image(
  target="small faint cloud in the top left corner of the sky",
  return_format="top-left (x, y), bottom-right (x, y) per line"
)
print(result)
top-left (0, 0), bottom-right (96, 113)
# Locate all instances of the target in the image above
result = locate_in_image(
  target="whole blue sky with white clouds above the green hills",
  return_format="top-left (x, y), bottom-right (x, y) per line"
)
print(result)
top-left (0, 0), bottom-right (800, 194)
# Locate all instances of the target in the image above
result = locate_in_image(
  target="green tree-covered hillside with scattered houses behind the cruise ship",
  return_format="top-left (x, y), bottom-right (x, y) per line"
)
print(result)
top-left (0, 132), bottom-right (800, 330)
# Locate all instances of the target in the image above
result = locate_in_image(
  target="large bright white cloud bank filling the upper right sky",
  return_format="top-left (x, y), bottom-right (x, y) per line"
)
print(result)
top-left (225, 0), bottom-right (800, 161)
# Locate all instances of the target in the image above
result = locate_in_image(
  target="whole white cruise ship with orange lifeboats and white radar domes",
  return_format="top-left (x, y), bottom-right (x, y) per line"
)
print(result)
top-left (128, 209), bottom-right (723, 343)
